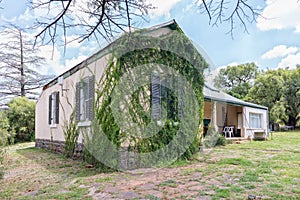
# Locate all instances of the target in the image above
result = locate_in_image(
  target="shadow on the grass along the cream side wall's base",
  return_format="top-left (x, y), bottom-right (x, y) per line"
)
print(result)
top-left (16, 147), bottom-right (113, 178)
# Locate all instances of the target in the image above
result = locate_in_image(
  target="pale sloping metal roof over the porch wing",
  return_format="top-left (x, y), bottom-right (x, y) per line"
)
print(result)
top-left (203, 83), bottom-right (268, 110)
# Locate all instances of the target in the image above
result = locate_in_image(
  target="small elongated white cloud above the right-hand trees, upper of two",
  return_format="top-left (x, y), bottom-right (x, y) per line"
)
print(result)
top-left (261, 45), bottom-right (298, 59)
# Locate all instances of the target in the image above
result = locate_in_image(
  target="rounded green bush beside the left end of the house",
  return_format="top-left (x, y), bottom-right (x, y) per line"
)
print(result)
top-left (7, 97), bottom-right (35, 142)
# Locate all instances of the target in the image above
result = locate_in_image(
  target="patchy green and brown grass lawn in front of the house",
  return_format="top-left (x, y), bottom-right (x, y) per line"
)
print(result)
top-left (0, 131), bottom-right (300, 199)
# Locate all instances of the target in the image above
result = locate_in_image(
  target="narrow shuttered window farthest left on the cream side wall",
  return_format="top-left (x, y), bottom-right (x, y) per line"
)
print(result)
top-left (49, 92), bottom-right (59, 125)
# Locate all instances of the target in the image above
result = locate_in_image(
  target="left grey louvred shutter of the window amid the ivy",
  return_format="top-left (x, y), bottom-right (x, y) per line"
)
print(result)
top-left (151, 73), bottom-right (161, 120)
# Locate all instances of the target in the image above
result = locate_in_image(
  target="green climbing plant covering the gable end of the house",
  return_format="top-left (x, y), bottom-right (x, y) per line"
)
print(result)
top-left (83, 25), bottom-right (207, 170)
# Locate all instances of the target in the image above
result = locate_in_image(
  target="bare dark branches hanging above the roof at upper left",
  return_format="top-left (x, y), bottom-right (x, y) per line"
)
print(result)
top-left (32, 0), bottom-right (153, 46)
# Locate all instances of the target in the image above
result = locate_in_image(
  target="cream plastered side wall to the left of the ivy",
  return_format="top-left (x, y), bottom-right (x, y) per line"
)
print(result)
top-left (35, 55), bottom-right (109, 143)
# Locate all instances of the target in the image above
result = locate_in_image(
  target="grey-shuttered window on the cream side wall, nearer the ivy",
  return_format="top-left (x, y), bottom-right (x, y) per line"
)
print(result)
top-left (76, 76), bottom-right (95, 122)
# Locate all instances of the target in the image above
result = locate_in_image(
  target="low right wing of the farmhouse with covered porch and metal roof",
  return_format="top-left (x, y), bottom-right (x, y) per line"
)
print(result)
top-left (203, 84), bottom-right (268, 139)
